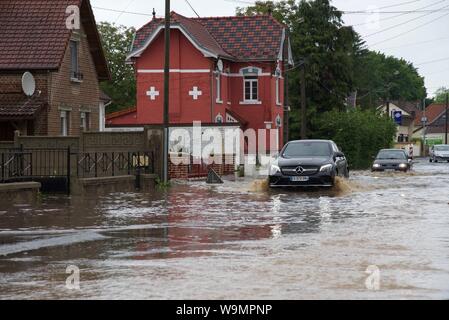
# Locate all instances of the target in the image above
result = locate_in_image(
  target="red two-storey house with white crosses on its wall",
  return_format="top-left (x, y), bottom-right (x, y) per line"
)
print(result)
top-left (106, 12), bottom-right (293, 152)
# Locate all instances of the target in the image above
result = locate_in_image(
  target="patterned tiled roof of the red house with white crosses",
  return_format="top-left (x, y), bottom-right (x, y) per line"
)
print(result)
top-left (133, 12), bottom-right (285, 61)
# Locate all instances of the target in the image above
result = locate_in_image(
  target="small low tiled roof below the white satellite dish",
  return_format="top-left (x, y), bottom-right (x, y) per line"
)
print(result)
top-left (0, 94), bottom-right (45, 119)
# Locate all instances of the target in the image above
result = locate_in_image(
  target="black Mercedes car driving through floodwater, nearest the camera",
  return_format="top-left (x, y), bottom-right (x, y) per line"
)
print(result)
top-left (269, 140), bottom-right (349, 188)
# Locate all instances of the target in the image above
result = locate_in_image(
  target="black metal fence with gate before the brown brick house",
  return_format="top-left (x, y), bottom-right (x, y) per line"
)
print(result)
top-left (0, 147), bottom-right (154, 193)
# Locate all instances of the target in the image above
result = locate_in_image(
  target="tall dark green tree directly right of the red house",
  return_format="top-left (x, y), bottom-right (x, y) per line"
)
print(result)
top-left (237, 0), bottom-right (363, 138)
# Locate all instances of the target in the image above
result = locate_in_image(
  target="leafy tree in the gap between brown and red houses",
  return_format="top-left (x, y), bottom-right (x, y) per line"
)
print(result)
top-left (98, 22), bottom-right (136, 112)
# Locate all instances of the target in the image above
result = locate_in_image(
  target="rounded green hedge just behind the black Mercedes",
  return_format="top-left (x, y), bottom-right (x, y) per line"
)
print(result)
top-left (313, 109), bottom-right (397, 169)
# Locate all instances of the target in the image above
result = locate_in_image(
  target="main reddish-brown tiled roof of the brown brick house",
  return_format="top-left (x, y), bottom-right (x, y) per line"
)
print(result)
top-left (0, 0), bottom-right (109, 79)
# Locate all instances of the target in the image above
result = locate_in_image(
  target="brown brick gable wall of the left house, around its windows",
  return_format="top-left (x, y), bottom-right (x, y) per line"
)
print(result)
top-left (48, 23), bottom-right (100, 135)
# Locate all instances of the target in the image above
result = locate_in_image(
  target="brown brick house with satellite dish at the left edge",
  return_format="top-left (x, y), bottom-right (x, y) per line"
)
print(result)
top-left (0, 0), bottom-right (110, 141)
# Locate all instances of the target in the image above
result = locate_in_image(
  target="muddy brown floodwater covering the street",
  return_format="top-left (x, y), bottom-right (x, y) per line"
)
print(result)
top-left (0, 160), bottom-right (449, 299)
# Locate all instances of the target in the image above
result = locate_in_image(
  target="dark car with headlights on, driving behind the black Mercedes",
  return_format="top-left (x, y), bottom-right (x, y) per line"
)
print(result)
top-left (371, 149), bottom-right (412, 172)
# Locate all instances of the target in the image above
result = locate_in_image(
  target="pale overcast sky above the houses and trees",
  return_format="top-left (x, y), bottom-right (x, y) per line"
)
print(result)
top-left (91, 0), bottom-right (449, 95)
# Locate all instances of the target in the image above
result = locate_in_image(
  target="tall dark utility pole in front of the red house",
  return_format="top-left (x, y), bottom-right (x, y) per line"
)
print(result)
top-left (162, 0), bottom-right (170, 183)
